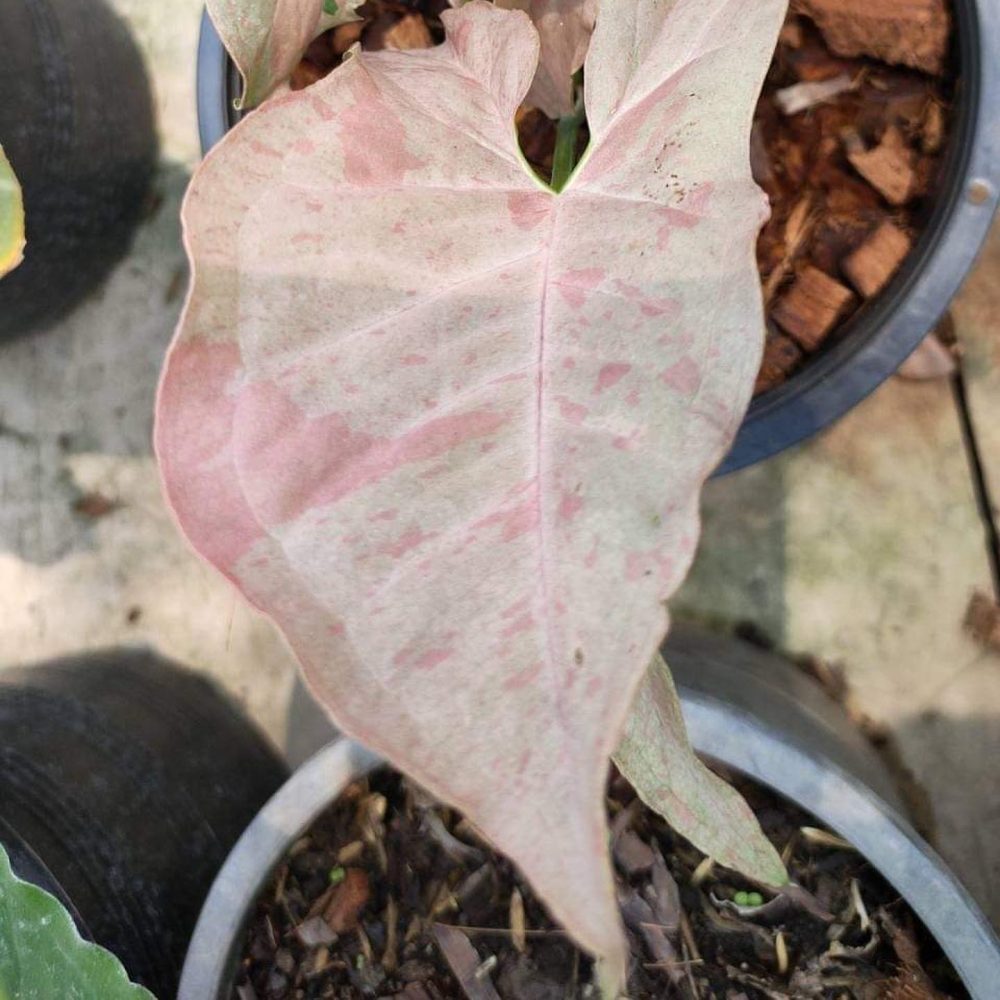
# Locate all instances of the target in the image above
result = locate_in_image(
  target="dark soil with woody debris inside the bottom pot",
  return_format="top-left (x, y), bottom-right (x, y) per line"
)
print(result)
top-left (232, 770), bottom-right (967, 1000)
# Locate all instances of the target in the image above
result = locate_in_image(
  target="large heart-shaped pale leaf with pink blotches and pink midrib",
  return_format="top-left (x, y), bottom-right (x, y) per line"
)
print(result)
top-left (156, 0), bottom-right (784, 981)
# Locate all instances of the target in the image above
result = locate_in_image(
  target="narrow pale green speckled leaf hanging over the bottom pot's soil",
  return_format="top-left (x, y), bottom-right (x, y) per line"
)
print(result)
top-left (614, 654), bottom-right (788, 886)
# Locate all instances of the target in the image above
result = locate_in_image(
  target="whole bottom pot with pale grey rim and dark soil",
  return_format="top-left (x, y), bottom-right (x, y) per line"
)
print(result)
top-left (179, 628), bottom-right (1000, 1000)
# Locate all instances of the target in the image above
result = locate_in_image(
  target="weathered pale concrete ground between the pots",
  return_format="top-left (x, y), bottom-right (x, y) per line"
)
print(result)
top-left (0, 0), bottom-right (1000, 923)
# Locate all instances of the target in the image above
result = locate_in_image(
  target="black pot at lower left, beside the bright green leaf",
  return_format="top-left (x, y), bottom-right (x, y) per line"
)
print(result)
top-left (0, 651), bottom-right (287, 998)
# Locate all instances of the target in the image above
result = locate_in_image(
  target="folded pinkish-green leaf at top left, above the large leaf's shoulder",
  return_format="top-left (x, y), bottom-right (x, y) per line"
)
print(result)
top-left (206, 0), bottom-right (364, 108)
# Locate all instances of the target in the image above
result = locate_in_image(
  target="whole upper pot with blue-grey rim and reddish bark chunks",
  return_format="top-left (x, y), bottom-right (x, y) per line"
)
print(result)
top-left (191, 0), bottom-right (1000, 472)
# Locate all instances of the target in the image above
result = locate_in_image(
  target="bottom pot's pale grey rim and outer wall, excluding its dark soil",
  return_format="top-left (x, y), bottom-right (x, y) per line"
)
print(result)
top-left (179, 627), bottom-right (1000, 1000)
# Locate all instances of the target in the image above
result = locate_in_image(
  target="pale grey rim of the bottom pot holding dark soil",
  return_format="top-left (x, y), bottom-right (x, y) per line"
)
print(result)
top-left (178, 679), bottom-right (1000, 1000)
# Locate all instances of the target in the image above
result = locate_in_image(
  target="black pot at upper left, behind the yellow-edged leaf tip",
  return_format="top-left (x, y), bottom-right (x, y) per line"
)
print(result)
top-left (0, 0), bottom-right (156, 340)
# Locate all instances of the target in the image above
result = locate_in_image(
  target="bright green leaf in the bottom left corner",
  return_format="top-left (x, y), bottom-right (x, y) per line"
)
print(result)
top-left (0, 846), bottom-right (155, 1000)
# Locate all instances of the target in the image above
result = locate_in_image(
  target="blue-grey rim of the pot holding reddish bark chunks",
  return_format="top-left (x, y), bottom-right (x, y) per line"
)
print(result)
top-left (191, 0), bottom-right (1000, 474)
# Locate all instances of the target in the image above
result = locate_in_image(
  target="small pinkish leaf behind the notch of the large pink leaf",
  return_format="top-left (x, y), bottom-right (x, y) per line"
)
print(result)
top-left (495, 0), bottom-right (592, 118)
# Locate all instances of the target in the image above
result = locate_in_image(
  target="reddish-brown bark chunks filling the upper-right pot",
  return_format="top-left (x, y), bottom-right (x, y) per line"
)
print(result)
top-left (292, 0), bottom-right (956, 394)
